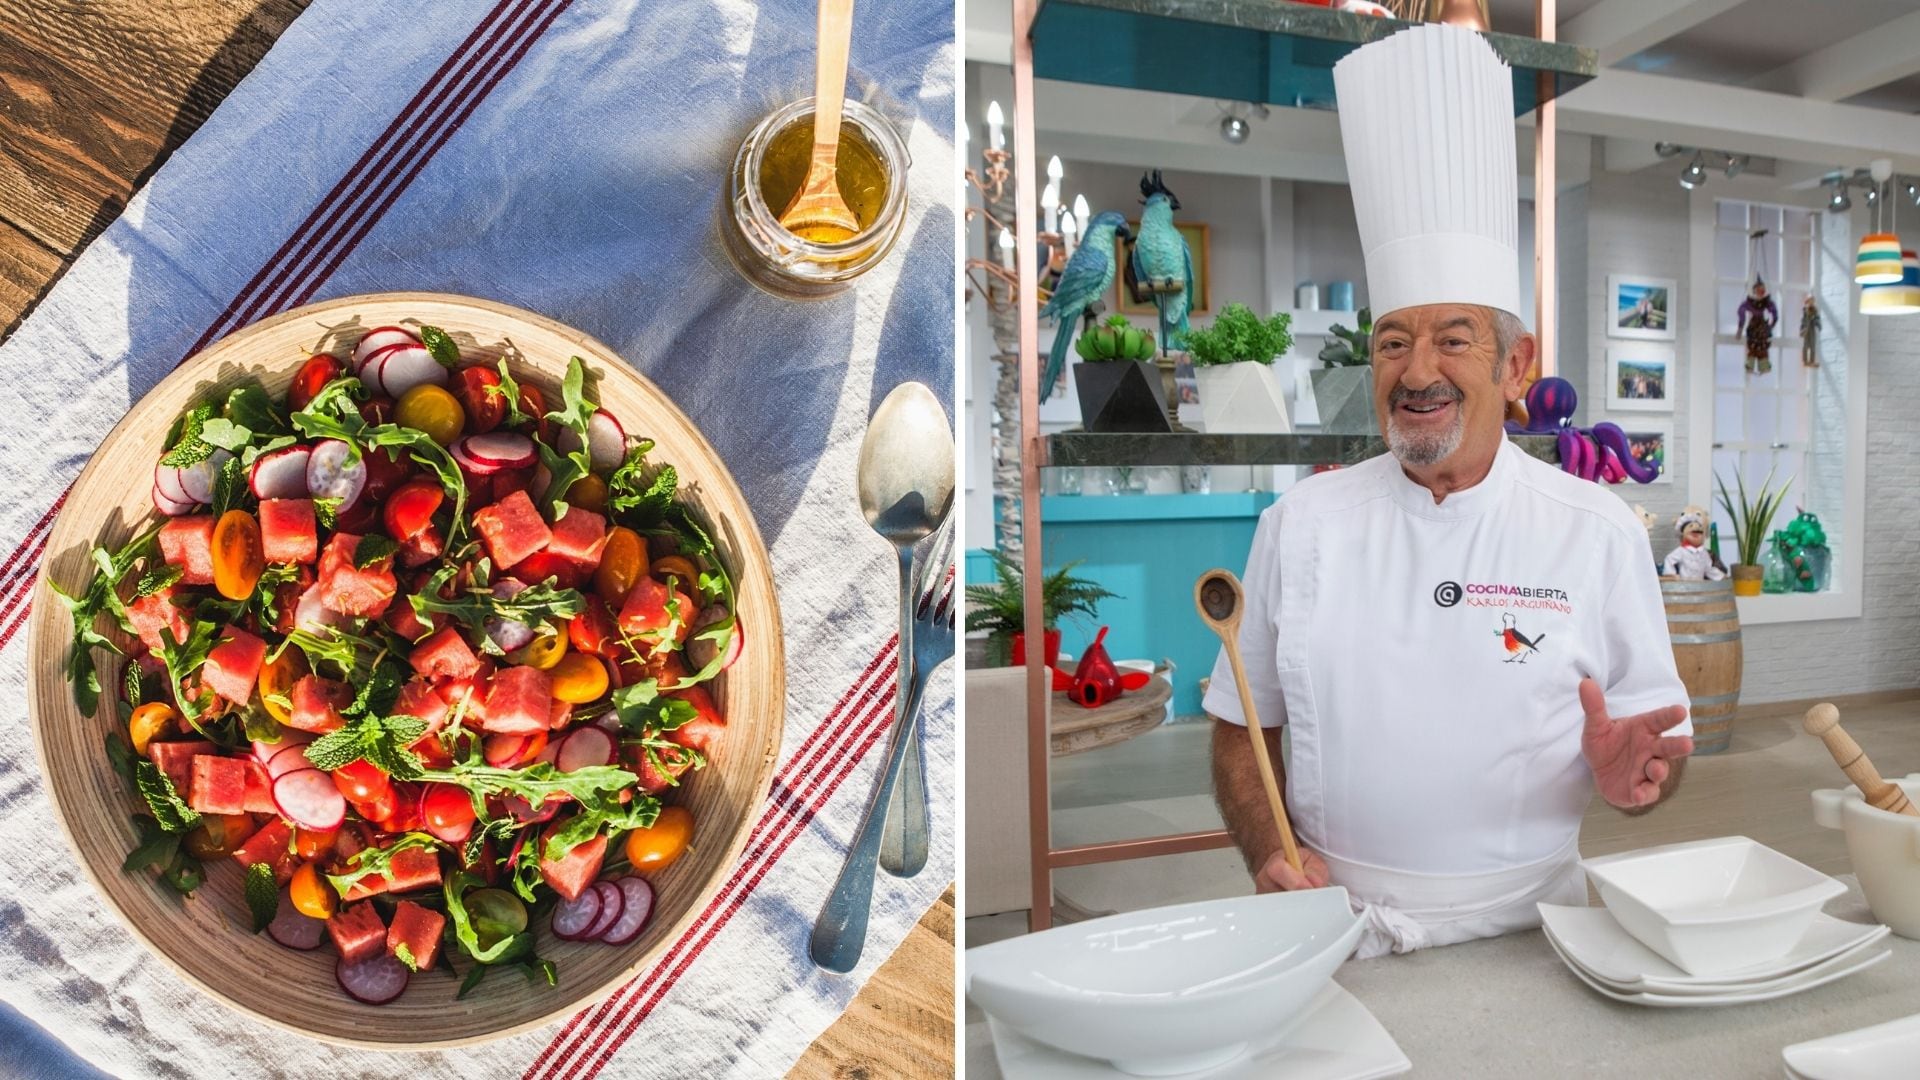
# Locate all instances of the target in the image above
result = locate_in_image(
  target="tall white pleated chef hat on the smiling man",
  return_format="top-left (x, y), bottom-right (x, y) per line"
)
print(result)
top-left (1332, 23), bottom-right (1521, 317)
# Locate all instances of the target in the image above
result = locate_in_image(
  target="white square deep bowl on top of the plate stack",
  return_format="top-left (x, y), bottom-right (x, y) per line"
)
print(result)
top-left (1580, 836), bottom-right (1847, 974)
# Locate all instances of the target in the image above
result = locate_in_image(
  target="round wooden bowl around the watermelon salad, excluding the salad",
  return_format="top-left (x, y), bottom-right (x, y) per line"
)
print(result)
top-left (27, 292), bottom-right (793, 1049)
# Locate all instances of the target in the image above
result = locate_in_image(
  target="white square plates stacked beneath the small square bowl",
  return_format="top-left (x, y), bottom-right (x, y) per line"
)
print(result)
top-left (1536, 903), bottom-right (1889, 994)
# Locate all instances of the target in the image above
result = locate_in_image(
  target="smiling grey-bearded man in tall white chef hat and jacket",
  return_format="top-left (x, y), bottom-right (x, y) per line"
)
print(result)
top-left (1204, 25), bottom-right (1693, 957)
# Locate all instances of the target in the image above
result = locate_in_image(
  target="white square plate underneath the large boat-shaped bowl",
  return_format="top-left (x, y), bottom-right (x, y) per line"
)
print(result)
top-left (987, 982), bottom-right (1413, 1080)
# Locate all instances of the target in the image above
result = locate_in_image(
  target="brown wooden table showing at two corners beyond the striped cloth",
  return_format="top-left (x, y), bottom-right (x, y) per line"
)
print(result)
top-left (0, 0), bottom-right (954, 1078)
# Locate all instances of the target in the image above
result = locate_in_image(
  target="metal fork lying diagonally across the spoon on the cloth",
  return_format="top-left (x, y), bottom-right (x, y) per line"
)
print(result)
top-left (806, 573), bottom-right (958, 972)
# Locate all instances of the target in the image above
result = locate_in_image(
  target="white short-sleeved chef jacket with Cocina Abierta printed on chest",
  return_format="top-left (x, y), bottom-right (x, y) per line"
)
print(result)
top-left (1202, 438), bottom-right (1693, 955)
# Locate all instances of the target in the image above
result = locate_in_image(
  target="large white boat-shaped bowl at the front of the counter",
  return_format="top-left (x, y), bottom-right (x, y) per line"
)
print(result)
top-left (966, 886), bottom-right (1361, 1076)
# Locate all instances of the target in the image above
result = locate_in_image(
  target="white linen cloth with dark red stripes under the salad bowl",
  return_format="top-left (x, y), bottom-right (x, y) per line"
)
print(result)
top-left (0, 0), bottom-right (956, 1080)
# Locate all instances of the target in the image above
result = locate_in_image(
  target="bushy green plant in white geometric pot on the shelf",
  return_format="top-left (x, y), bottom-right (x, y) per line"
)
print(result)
top-left (1187, 304), bottom-right (1294, 434)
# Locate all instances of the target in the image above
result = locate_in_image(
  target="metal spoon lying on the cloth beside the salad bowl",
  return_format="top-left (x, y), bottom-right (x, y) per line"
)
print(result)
top-left (858, 382), bottom-right (954, 878)
